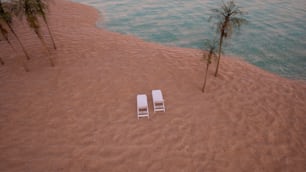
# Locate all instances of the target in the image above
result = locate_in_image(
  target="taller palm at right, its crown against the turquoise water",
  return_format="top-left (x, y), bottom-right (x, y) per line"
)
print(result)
top-left (211, 0), bottom-right (247, 76)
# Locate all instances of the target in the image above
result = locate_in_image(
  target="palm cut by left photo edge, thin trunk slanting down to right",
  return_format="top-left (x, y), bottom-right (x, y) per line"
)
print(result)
top-left (0, 0), bottom-right (30, 60)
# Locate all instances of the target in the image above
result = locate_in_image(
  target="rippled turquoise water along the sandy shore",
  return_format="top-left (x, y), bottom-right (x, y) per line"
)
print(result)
top-left (73, 0), bottom-right (306, 80)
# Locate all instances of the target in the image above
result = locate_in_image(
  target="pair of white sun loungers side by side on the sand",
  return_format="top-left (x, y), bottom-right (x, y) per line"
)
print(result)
top-left (137, 90), bottom-right (166, 119)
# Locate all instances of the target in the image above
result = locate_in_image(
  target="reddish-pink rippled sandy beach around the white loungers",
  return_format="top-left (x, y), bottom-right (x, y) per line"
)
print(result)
top-left (0, 0), bottom-right (306, 172)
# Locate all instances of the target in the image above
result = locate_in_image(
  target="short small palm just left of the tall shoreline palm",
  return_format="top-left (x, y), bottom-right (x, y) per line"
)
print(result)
top-left (202, 40), bottom-right (217, 93)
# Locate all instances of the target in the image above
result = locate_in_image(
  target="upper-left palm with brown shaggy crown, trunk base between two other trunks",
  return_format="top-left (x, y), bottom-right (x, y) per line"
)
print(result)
top-left (17, 0), bottom-right (54, 66)
